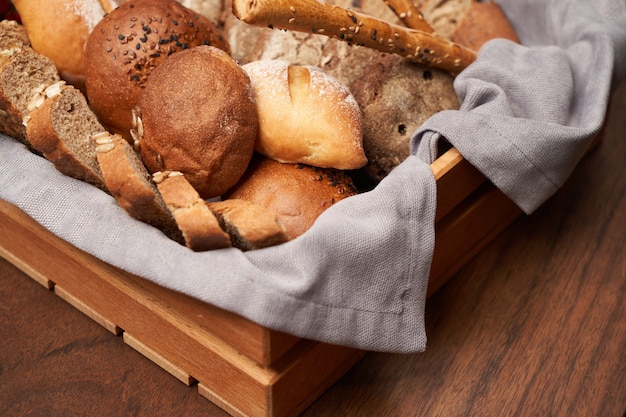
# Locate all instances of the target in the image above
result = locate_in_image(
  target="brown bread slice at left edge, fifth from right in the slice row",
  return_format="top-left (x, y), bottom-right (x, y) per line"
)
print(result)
top-left (0, 46), bottom-right (60, 149)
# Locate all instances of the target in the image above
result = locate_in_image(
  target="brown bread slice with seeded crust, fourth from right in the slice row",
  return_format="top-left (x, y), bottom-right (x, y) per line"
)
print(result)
top-left (26, 81), bottom-right (107, 191)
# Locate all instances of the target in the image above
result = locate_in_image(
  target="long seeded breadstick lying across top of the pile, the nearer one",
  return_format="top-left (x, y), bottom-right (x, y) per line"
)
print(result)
top-left (233, 0), bottom-right (476, 74)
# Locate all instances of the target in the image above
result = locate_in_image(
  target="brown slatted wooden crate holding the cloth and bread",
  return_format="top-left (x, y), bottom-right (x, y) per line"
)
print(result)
top-left (0, 148), bottom-right (521, 417)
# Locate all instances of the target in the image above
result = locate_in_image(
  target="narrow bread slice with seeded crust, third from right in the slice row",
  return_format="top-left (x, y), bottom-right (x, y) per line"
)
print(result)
top-left (92, 132), bottom-right (184, 240)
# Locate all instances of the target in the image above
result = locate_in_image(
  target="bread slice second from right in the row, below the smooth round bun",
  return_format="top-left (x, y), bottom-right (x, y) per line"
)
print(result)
top-left (153, 171), bottom-right (231, 252)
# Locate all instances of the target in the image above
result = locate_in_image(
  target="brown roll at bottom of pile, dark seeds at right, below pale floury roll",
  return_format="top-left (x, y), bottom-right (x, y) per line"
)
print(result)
top-left (224, 156), bottom-right (357, 239)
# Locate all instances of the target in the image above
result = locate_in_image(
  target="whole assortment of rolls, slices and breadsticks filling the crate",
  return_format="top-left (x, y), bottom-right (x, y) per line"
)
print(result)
top-left (0, 0), bottom-right (516, 251)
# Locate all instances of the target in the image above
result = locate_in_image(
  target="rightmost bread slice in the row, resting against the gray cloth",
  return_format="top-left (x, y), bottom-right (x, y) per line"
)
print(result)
top-left (207, 199), bottom-right (289, 251)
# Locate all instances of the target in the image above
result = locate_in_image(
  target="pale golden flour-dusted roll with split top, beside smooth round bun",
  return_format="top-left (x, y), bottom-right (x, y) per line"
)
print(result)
top-left (243, 60), bottom-right (367, 170)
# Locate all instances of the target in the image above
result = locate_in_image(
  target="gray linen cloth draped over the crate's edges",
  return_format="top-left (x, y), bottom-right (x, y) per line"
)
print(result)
top-left (0, 0), bottom-right (626, 353)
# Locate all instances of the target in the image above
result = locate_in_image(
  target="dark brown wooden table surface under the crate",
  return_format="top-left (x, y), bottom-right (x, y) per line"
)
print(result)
top-left (0, 79), bottom-right (626, 417)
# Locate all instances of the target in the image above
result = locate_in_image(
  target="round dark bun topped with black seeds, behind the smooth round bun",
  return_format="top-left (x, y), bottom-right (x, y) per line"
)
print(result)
top-left (85, 0), bottom-right (229, 140)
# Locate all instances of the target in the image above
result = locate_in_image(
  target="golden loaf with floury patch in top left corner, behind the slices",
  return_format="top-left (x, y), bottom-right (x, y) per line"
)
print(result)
top-left (13, 0), bottom-right (111, 92)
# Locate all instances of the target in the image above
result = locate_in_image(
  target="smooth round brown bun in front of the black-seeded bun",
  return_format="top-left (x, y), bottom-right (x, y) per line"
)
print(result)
top-left (133, 46), bottom-right (258, 199)
